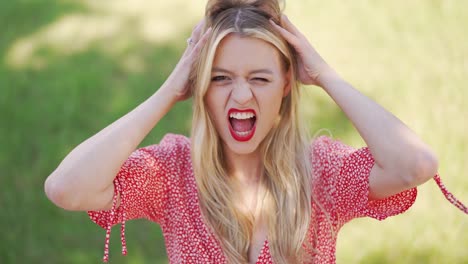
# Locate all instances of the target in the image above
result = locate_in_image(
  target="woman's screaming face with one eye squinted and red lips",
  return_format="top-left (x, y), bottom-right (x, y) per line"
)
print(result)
top-left (205, 33), bottom-right (290, 154)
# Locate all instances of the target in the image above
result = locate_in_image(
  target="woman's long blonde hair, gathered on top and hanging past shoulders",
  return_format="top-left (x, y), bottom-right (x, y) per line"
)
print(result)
top-left (191, 0), bottom-right (312, 263)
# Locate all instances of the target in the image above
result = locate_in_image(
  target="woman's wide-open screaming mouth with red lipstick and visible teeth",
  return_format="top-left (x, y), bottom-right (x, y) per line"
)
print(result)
top-left (228, 109), bottom-right (257, 141)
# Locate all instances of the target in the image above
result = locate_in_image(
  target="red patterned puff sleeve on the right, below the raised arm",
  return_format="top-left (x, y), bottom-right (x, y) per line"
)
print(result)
top-left (311, 136), bottom-right (417, 224)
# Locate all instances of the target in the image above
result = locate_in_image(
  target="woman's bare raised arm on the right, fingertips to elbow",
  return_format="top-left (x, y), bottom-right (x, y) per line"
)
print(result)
top-left (272, 16), bottom-right (438, 198)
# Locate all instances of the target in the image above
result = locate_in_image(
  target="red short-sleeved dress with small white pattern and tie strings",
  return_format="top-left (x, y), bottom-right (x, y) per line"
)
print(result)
top-left (88, 134), bottom-right (466, 263)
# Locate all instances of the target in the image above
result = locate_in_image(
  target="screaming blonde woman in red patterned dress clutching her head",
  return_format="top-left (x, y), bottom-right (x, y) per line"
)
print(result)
top-left (45, 0), bottom-right (466, 263)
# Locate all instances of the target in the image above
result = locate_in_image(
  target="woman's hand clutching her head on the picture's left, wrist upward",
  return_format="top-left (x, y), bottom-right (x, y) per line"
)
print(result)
top-left (166, 19), bottom-right (211, 101)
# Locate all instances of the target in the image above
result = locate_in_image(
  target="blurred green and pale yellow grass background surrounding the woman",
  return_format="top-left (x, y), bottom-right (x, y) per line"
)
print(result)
top-left (0, 0), bottom-right (468, 264)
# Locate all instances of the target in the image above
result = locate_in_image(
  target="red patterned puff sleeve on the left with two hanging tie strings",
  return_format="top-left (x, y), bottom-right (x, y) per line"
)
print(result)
top-left (88, 134), bottom-right (186, 262)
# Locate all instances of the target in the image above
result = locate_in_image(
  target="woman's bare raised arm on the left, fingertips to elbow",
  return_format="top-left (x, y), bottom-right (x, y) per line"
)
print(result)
top-left (44, 21), bottom-right (211, 211)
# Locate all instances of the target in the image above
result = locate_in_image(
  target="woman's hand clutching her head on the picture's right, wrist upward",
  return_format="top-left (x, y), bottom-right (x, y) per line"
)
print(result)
top-left (270, 15), bottom-right (335, 86)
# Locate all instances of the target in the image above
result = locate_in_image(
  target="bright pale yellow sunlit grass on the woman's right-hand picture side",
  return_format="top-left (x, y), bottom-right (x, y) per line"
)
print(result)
top-left (290, 1), bottom-right (468, 263)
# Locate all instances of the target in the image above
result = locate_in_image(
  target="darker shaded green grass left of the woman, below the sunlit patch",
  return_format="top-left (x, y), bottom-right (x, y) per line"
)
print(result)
top-left (0, 1), bottom-right (191, 263)
